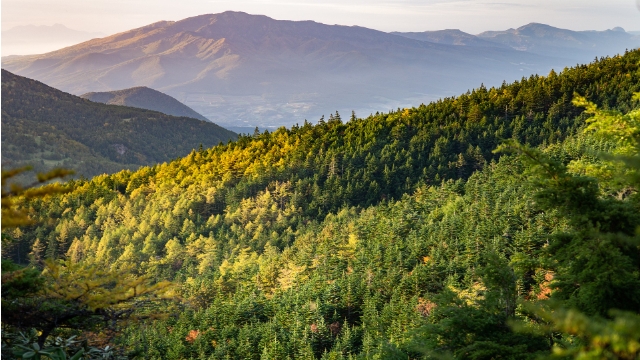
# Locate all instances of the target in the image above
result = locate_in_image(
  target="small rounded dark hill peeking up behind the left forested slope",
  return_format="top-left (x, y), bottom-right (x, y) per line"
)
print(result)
top-left (80, 86), bottom-right (209, 121)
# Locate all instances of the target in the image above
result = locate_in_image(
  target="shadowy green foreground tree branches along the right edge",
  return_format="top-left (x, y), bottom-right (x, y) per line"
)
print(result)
top-left (500, 93), bottom-right (640, 359)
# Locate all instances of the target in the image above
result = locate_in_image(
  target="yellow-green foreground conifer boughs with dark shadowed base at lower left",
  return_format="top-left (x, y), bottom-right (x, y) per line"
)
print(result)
top-left (2, 260), bottom-right (171, 345)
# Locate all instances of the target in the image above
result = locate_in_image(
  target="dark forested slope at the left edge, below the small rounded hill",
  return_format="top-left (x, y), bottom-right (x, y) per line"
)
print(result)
top-left (2, 70), bottom-right (236, 177)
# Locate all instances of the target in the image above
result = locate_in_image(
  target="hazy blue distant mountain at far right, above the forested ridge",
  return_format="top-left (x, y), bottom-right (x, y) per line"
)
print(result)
top-left (478, 23), bottom-right (640, 62)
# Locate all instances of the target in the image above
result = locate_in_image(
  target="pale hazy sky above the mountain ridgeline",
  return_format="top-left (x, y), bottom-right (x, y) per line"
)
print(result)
top-left (2, 0), bottom-right (640, 34)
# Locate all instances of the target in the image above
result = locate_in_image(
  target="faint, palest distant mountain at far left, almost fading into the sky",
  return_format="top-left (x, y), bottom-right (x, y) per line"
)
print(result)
top-left (2, 24), bottom-right (105, 56)
